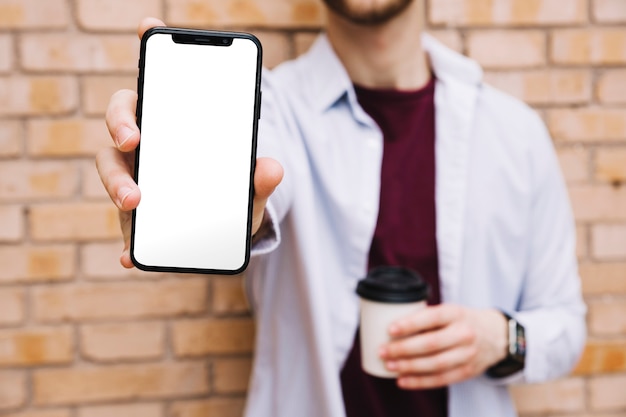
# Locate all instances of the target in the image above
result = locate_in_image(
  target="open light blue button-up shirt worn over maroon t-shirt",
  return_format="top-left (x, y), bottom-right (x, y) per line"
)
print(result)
top-left (246, 35), bottom-right (585, 417)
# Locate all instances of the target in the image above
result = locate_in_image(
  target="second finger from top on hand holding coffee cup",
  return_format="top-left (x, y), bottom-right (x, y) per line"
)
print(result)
top-left (380, 323), bottom-right (476, 359)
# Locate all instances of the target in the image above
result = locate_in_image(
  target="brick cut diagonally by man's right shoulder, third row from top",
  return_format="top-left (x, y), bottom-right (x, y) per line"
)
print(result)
top-left (485, 69), bottom-right (591, 105)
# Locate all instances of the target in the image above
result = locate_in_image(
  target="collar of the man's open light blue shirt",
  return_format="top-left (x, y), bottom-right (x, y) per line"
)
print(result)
top-left (300, 33), bottom-right (482, 112)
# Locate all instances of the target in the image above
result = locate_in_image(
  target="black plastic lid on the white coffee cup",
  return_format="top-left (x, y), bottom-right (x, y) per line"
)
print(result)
top-left (356, 266), bottom-right (429, 303)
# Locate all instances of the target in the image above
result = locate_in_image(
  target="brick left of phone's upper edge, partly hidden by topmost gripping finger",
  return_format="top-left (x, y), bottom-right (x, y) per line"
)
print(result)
top-left (81, 75), bottom-right (137, 116)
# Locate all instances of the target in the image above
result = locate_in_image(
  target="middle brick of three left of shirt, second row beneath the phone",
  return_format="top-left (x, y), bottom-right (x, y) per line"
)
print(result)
top-left (80, 322), bottom-right (165, 360)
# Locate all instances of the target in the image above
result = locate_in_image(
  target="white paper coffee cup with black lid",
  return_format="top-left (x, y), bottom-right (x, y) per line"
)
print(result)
top-left (356, 266), bottom-right (428, 378)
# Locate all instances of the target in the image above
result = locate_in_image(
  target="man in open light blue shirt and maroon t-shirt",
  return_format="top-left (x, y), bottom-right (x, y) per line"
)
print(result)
top-left (97, 0), bottom-right (585, 417)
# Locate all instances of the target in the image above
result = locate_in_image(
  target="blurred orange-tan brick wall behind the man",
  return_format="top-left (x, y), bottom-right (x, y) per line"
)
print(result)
top-left (0, 0), bottom-right (626, 417)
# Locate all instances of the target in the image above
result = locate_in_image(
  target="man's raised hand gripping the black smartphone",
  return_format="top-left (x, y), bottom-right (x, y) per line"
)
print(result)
top-left (96, 18), bottom-right (283, 268)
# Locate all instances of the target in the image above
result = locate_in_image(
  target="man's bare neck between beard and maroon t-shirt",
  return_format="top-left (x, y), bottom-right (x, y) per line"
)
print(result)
top-left (327, 1), bottom-right (430, 90)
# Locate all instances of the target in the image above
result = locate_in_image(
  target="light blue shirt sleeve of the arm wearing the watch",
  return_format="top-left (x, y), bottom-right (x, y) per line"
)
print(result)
top-left (513, 111), bottom-right (586, 382)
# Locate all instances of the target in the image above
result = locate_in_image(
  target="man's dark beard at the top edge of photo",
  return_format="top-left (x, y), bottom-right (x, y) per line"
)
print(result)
top-left (322, 0), bottom-right (413, 26)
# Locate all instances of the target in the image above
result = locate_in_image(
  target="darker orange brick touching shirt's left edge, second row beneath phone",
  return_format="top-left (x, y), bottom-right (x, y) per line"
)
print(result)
top-left (172, 318), bottom-right (254, 357)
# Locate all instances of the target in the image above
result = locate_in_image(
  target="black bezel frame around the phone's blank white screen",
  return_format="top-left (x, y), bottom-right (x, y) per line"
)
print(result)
top-left (130, 26), bottom-right (263, 275)
